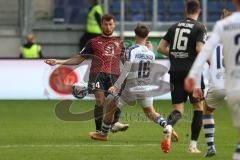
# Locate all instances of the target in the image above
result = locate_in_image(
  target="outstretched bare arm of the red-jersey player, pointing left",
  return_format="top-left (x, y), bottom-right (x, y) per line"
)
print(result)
top-left (44, 55), bottom-right (85, 66)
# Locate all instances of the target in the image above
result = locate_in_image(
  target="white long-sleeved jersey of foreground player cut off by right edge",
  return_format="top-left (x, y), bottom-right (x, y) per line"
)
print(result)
top-left (189, 12), bottom-right (240, 91)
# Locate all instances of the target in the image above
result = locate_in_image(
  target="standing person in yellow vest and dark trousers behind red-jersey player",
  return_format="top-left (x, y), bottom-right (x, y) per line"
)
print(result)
top-left (79, 0), bottom-right (104, 51)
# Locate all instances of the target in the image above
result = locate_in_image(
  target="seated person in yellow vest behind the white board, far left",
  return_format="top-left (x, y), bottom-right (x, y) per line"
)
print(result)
top-left (20, 34), bottom-right (43, 59)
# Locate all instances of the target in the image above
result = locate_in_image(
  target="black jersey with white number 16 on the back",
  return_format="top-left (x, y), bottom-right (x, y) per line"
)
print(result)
top-left (163, 18), bottom-right (207, 72)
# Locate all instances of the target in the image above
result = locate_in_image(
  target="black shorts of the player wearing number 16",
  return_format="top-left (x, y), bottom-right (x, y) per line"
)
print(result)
top-left (170, 72), bottom-right (204, 104)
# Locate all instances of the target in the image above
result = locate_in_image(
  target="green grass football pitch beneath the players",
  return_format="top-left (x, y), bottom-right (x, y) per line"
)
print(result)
top-left (0, 101), bottom-right (237, 160)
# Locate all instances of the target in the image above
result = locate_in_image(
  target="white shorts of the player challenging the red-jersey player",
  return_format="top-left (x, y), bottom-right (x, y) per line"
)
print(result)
top-left (118, 90), bottom-right (153, 108)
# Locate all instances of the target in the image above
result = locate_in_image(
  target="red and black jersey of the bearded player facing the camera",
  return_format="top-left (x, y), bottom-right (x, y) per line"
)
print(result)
top-left (80, 36), bottom-right (124, 75)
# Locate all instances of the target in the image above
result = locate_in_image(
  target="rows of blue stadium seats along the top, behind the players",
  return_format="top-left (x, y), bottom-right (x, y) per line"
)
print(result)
top-left (51, 0), bottom-right (234, 24)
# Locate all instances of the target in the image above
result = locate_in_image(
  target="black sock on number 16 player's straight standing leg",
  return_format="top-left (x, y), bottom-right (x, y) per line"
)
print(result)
top-left (191, 111), bottom-right (203, 141)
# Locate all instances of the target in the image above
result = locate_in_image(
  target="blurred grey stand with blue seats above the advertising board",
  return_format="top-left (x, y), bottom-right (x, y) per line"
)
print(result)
top-left (0, 0), bottom-right (233, 58)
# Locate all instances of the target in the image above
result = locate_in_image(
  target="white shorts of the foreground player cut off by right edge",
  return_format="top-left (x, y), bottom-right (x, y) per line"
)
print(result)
top-left (227, 91), bottom-right (240, 129)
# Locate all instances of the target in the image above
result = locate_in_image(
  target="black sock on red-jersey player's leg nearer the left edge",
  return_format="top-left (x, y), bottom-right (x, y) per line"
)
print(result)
top-left (94, 105), bottom-right (103, 131)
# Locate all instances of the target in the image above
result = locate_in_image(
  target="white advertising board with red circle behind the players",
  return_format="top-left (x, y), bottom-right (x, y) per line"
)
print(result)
top-left (0, 60), bottom-right (170, 100)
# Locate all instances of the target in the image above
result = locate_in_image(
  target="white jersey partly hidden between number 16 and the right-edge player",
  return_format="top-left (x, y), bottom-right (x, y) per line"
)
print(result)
top-left (209, 45), bottom-right (225, 90)
